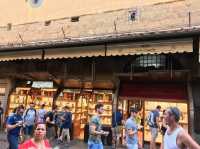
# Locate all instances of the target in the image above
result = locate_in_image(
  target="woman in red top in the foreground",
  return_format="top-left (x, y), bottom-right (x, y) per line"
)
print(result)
top-left (19, 123), bottom-right (52, 149)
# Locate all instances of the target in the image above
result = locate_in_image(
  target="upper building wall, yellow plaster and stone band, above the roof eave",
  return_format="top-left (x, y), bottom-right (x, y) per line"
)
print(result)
top-left (0, 0), bottom-right (200, 46)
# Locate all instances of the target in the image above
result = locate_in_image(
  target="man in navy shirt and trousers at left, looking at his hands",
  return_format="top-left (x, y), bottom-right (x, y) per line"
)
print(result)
top-left (6, 106), bottom-right (24, 149)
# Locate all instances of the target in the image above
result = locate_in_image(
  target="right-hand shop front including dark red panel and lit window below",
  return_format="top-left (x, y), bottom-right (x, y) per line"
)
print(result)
top-left (118, 81), bottom-right (189, 145)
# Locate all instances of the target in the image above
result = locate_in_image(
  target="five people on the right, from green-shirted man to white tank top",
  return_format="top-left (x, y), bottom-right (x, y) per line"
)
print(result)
top-left (88, 104), bottom-right (200, 149)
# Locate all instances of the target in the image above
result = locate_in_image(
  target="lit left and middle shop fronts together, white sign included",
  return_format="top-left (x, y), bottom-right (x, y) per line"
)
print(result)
top-left (7, 81), bottom-right (113, 143)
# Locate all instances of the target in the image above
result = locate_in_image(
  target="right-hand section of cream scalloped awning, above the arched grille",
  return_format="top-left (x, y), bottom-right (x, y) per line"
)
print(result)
top-left (106, 38), bottom-right (193, 56)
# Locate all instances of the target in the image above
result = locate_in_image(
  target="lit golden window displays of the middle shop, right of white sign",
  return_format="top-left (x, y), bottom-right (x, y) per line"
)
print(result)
top-left (56, 89), bottom-right (112, 139)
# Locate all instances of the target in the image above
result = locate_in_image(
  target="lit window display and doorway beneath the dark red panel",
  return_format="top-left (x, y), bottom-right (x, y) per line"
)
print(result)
top-left (118, 98), bottom-right (188, 146)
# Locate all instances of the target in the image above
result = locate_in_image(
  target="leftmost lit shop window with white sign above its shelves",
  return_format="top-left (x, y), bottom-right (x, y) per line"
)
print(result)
top-left (6, 81), bottom-right (57, 115)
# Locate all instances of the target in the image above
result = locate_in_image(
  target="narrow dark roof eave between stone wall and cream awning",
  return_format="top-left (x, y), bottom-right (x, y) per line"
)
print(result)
top-left (0, 26), bottom-right (200, 51)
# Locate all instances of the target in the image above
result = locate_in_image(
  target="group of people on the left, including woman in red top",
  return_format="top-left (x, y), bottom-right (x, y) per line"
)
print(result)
top-left (6, 102), bottom-right (72, 149)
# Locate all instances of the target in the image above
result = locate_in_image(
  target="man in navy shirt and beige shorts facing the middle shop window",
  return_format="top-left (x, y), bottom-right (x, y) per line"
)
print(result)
top-left (60, 106), bottom-right (72, 144)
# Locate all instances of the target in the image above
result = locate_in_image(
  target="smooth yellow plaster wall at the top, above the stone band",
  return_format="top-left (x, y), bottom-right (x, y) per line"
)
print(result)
top-left (0, 0), bottom-right (184, 26)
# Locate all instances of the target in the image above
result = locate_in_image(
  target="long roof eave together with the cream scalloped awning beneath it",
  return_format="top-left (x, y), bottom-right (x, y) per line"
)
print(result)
top-left (0, 28), bottom-right (200, 61)
